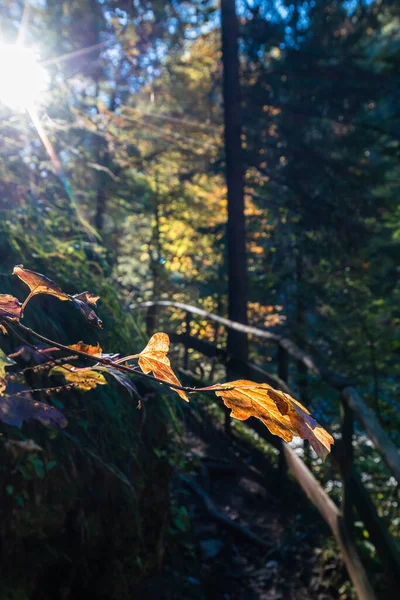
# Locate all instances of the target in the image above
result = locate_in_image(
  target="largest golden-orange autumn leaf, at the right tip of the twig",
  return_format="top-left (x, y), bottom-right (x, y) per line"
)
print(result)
top-left (206, 380), bottom-right (334, 459)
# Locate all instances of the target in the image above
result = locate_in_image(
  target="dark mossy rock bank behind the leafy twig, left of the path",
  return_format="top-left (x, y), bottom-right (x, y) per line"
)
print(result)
top-left (0, 225), bottom-right (174, 600)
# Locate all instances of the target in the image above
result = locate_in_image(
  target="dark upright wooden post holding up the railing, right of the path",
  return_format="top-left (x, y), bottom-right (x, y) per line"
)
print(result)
top-left (341, 394), bottom-right (354, 536)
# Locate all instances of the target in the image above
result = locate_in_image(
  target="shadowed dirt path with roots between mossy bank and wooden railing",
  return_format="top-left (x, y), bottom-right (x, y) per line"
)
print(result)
top-left (140, 406), bottom-right (343, 600)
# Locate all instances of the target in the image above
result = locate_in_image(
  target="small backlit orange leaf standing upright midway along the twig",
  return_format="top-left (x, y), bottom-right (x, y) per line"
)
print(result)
top-left (133, 332), bottom-right (189, 402)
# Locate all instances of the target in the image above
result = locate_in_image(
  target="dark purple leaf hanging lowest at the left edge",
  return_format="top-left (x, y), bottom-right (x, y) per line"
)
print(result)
top-left (0, 384), bottom-right (67, 427)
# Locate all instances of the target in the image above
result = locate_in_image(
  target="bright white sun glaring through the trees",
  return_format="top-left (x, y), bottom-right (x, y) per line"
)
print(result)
top-left (0, 42), bottom-right (48, 111)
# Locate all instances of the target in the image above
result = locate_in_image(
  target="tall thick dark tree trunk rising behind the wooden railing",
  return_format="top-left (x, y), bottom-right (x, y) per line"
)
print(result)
top-left (221, 0), bottom-right (248, 375)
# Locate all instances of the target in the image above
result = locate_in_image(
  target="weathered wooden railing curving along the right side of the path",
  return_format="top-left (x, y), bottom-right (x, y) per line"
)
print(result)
top-left (138, 301), bottom-right (400, 600)
